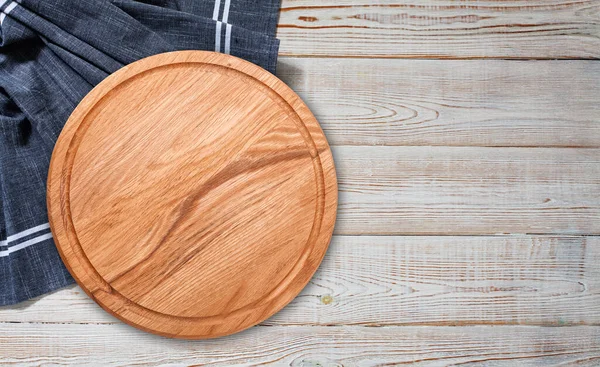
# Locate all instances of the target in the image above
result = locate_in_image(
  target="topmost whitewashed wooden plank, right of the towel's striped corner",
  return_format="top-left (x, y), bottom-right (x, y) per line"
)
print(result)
top-left (277, 0), bottom-right (600, 59)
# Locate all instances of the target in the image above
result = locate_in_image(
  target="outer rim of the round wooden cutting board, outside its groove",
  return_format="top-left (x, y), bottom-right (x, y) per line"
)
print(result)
top-left (47, 51), bottom-right (337, 339)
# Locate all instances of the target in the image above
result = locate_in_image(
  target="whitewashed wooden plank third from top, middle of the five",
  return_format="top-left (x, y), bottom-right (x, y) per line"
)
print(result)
top-left (333, 147), bottom-right (600, 235)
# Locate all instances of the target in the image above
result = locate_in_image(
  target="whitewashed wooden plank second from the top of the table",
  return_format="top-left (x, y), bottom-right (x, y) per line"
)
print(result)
top-left (278, 58), bottom-right (600, 147)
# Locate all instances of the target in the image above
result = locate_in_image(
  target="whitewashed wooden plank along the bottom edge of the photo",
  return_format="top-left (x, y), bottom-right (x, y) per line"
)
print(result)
top-left (0, 324), bottom-right (600, 366)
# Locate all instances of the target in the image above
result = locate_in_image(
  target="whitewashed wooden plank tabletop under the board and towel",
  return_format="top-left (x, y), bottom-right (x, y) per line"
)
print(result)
top-left (0, 0), bottom-right (600, 366)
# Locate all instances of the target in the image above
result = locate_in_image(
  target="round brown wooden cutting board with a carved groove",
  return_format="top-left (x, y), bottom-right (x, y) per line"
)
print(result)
top-left (48, 51), bottom-right (337, 339)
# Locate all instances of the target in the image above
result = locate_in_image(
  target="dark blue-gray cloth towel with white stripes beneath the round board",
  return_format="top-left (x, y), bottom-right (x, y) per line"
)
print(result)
top-left (0, 0), bottom-right (279, 305)
